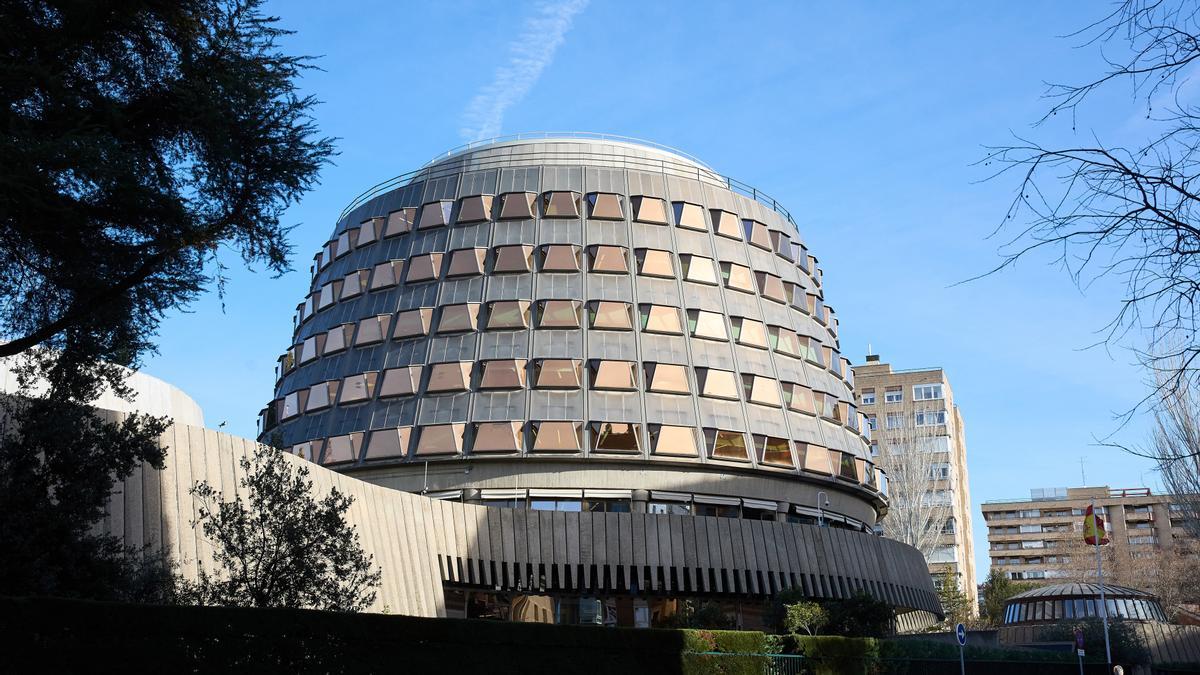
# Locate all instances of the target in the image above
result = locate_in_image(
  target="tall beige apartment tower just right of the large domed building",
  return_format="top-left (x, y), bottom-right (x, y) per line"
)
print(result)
top-left (853, 354), bottom-right (979, 611)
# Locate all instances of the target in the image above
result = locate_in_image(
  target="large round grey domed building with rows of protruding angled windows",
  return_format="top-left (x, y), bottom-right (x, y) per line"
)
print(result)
top-left (260, 135), bottom-right (940, 629)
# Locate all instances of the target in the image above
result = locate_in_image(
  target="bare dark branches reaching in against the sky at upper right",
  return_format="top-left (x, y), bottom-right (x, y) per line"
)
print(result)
top-left (983, 0), bottom-right (1200, 412)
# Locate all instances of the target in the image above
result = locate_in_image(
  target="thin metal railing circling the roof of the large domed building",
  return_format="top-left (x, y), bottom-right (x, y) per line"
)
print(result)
top-left (337, 131), bottom-right (799, 232)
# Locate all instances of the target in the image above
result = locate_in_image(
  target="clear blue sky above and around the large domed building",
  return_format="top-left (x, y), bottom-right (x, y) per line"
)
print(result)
top-left (144, 0), bottom-right (1158, 580)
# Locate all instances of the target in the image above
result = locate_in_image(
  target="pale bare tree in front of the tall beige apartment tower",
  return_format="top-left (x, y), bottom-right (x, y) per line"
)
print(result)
top-left (876, 413), bottom-right (953, 560)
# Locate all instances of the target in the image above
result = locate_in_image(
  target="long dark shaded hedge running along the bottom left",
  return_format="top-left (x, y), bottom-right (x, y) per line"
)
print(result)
top-left (0, 598), bottom-right (684, 675)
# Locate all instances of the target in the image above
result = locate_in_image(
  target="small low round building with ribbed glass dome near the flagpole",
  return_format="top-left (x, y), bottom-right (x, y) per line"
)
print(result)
top-left (1004, 584), bottom-right (1166, 626)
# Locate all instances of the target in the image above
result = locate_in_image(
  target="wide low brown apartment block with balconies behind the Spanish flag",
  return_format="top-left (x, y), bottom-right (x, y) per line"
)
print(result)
top-left (983, 486), bottom-right (1184, 581)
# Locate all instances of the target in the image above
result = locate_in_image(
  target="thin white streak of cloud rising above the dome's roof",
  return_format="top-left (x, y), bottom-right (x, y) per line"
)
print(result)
top-left (458, 0), bottom-right (588, 141)
